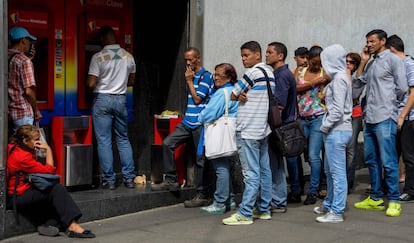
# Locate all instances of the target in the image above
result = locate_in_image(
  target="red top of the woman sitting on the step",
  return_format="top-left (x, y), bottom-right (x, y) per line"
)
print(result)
top-left (7, 144), bottom-right (56, 195)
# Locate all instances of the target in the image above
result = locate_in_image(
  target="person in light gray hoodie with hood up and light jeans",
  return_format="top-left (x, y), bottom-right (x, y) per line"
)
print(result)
top-left (313, 44), bottom-right (352, 223)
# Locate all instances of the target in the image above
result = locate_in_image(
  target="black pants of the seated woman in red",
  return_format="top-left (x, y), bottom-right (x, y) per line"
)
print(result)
top-left (8, 184), bottom-right (82, 231)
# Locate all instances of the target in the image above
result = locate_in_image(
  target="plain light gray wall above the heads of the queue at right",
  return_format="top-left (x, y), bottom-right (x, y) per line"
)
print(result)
top-left (202, 0), bottom-right (414, 77)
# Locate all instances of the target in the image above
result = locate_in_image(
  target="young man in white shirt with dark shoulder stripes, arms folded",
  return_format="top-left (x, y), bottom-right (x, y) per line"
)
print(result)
top-left (223, 41), bottom-right (275, 225)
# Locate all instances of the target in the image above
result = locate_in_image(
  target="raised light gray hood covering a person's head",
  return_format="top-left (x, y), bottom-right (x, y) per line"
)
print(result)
top-left (321, 44), bottom-right (346, 78)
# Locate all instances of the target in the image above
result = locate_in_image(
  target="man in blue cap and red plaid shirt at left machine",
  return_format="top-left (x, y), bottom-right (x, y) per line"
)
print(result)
top-left (7, 26), bottom-right (42, 135)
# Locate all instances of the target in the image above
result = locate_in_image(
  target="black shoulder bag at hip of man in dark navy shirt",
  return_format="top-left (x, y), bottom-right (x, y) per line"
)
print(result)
top-left (269, 121), bottom-right (307, 157)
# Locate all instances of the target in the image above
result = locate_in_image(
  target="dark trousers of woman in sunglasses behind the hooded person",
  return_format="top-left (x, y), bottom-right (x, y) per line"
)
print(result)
top-left (346, 116), bottom-right (362, 191)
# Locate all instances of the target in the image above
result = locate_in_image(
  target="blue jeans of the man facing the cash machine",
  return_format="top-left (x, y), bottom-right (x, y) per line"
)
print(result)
top-left (92, 94), bottom-right (135, 184)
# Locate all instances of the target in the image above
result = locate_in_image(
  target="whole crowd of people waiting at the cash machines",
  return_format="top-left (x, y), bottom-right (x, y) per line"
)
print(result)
top-left (7, 26), bottom-right (414, 238)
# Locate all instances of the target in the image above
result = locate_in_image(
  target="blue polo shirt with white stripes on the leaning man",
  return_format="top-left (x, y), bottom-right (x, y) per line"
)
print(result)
top-left (182, 68), bottom-right (214, 129)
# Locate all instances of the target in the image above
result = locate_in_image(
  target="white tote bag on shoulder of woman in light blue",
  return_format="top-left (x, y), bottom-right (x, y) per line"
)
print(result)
top-left (204, 89), bottom-right (237, 159)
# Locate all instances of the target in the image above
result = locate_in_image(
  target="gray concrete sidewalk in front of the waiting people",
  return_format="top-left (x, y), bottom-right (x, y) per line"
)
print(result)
top-left (3, 168), bottom-right (414, 243)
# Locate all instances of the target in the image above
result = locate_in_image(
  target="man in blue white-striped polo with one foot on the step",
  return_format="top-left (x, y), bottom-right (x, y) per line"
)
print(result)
top-left (151, 47), bottom-right (214, 207)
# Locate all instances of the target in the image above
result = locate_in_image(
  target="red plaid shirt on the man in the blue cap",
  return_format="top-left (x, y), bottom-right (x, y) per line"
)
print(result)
top-left (7, 49), bottom-right (36, 121)
